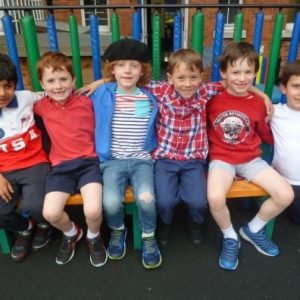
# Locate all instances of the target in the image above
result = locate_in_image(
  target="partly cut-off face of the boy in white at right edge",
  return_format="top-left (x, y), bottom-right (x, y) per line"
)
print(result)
top-left (280, 75), bottom-right (300, 111)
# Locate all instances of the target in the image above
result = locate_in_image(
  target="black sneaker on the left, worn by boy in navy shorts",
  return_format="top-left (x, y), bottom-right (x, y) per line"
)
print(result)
top-left (56, 225), bottom-right (83, 265)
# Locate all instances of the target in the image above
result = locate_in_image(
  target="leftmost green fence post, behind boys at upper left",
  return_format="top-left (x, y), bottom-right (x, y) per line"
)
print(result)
top-left (20, 16), bottom-right (42, 92)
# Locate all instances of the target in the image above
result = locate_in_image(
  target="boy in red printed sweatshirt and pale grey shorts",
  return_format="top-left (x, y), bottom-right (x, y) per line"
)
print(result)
top-left (207, 42), bottom-right (293, 270)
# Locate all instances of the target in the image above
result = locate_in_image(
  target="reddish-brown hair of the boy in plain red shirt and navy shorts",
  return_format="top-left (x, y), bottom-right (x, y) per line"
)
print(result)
top-left (37, 51), bottom-right (75, 80)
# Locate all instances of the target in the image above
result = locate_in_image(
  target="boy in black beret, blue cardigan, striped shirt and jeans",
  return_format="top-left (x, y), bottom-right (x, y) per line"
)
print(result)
top-left (92, 39), bottom-right (162, 269)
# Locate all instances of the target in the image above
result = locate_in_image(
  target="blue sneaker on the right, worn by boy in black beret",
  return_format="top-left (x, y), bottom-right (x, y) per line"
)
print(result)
top-left (142, 236), bottom-right (162, 269)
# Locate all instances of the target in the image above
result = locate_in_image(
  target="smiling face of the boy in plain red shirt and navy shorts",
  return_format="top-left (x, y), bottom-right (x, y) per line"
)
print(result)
top-left (41, 67), bottom-right (75, 104)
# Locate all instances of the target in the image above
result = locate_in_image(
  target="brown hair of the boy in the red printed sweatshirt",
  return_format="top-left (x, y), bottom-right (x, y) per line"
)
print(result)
top-left (219, 42), bottom-right (259, 73)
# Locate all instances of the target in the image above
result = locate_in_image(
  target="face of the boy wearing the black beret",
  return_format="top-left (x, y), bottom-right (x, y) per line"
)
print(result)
top-left (112, 60), bottom-right (143, 93)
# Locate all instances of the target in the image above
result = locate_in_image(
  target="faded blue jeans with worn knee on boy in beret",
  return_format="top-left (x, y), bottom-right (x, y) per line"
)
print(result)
top-left (100, 159), bottom-right (156, 233)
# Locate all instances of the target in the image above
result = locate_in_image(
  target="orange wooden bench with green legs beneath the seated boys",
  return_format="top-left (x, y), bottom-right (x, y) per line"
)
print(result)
top-left (0, 180), bottom-right (274, 254)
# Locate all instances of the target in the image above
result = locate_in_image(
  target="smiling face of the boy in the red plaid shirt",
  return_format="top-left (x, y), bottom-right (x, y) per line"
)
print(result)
top-left (167, 62), bottom-right (202, 99)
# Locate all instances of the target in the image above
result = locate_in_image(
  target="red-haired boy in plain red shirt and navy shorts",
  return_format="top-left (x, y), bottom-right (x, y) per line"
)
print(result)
top-left (34, 52), bottom-right (107, 267)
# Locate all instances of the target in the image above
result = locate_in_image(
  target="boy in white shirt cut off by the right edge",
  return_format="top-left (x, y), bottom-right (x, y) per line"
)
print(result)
top-left (271, 60), bottom-right (300, 225)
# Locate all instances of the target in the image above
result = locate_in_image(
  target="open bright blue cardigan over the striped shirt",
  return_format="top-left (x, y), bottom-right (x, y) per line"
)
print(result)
top-left (91, 82), bottom-right (158, 162)
